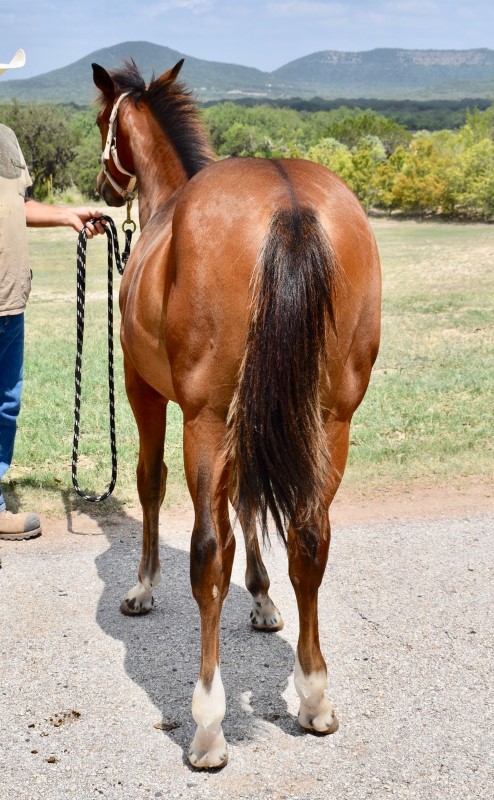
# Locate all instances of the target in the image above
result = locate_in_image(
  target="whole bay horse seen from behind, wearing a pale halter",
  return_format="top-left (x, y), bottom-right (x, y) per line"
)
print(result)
top-left (93, 61), bottom-right (381, 769)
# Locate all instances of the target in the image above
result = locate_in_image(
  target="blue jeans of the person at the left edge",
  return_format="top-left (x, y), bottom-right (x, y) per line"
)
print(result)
top-left (0, 314), bottom-right (24, 511)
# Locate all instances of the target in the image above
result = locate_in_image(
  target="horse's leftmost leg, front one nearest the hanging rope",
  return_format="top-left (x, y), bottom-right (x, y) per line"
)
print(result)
top-left (120, 364), bottom-right (167, 615)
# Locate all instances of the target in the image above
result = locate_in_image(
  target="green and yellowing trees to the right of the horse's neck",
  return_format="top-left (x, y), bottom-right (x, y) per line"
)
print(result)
top-left (204, 103), bottom-right (494, 220)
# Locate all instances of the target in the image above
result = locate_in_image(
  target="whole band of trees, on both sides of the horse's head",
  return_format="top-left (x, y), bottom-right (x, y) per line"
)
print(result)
top-left (0, 100), bottom-right (494, 220)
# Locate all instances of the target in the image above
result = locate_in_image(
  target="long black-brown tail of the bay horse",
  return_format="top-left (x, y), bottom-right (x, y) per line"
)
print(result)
top-left (227, 209), bottom-right (338, 541)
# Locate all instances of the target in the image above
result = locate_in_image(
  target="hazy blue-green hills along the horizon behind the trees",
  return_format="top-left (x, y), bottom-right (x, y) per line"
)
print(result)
top-left (0, 42), bottom-right (494, 106)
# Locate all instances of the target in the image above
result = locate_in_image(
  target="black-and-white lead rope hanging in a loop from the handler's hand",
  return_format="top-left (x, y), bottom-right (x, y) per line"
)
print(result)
top-left (72, 209), bottom-right (136, 503)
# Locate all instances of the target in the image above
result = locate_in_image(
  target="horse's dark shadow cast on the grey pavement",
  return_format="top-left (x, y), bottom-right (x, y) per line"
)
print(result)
top-left (75, 510), bottom-right (302, 765)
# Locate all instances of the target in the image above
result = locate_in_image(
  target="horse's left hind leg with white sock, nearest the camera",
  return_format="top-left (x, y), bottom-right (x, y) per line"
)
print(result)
top-left (184, 415), bottom-right (235, 769)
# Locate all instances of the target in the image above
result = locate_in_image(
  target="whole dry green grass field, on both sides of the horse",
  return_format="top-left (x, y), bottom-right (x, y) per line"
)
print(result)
top-left (4, 211), bottom-right (494, 515)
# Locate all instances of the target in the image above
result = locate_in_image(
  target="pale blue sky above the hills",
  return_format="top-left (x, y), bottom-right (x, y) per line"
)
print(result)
top-left (0, 0), bottom-right (494, 79)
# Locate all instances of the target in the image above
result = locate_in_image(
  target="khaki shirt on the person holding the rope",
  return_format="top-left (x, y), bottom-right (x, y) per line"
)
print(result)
top-left (0, 124), bottom-right (32, 316)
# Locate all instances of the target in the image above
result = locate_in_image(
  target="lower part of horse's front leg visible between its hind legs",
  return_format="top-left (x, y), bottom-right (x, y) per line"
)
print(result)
top-left (239, 514), bottom-right (283, 632)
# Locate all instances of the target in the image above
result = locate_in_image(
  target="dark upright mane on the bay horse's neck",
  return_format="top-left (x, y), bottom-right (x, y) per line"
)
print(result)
top-left (100, 59), bottom-right (214, 178)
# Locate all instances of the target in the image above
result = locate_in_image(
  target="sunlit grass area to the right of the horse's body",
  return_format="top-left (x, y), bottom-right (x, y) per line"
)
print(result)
top-left (346, 221), bottom-right (494, 494)
